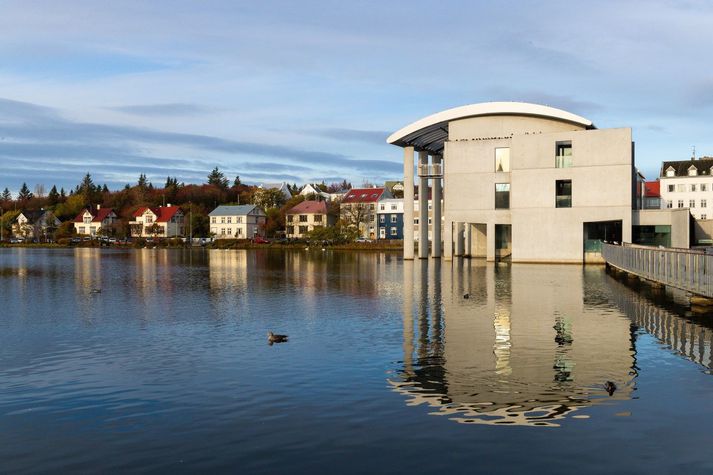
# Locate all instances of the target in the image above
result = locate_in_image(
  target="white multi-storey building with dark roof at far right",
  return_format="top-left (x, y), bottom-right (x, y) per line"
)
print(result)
top-left (659, 157), bottom-right (713, 219)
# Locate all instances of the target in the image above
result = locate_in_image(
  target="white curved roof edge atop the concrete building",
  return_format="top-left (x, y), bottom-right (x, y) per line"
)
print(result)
top-left (386, 102), bottom-right (595, 149)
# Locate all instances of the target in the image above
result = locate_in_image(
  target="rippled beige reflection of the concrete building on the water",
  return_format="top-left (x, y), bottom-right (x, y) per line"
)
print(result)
top-left (391, 261), bottom-right (635, 426)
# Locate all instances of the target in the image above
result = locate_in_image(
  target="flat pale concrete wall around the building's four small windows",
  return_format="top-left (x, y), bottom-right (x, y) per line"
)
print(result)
top-left (444, 116), bottom-right (633, 262)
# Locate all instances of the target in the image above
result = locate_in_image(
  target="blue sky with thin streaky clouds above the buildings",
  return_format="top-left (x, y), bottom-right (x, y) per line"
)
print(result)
top-left (0, 0), bottom-right (713, 190)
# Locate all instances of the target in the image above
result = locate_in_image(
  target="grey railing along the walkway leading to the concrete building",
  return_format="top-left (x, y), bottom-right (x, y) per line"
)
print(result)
top-left (602, 243), bottom-right (713, 298)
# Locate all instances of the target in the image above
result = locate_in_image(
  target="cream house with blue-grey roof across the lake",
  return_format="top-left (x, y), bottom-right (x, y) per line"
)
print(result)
top-left (208, 205), bottom-right (267, 239)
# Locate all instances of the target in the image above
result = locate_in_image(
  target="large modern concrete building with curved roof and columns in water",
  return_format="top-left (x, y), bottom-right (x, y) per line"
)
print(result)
top-left (387, 102), bottom-right (689, 263)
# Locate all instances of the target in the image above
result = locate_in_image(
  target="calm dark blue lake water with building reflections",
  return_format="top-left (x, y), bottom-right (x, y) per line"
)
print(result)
top-left (0, 249), bottom-right (713, 473)
